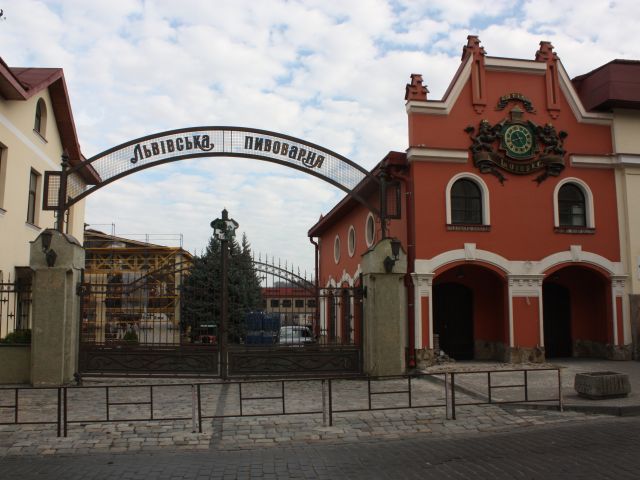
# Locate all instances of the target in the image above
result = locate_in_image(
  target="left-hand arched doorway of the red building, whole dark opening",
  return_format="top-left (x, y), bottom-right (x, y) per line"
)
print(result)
top-left (433, 263), bottom-right (508, 361)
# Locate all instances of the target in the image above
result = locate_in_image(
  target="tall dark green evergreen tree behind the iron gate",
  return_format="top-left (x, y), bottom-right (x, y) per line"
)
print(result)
top-left (180, 234), bottom-right (262, 343)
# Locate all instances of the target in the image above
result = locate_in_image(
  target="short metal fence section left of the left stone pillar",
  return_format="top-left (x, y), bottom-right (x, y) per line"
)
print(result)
top-left (0, 281), bottom-right (31, 343)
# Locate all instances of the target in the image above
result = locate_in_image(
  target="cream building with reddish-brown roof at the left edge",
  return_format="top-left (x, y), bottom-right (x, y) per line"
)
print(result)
top-left (0, 58), bottom-right (89, 282)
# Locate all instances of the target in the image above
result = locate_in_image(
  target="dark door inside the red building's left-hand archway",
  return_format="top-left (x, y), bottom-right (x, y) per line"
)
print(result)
top-left (433, 283), bottom-right (474, 360)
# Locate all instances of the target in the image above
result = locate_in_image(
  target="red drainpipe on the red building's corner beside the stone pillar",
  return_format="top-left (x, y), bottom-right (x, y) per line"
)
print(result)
top-left (394, 174), bottom-right (416, 368)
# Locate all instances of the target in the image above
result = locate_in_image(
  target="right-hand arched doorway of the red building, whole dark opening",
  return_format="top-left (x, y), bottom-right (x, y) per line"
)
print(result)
top-left (542, 265), bottom-right (613, 358)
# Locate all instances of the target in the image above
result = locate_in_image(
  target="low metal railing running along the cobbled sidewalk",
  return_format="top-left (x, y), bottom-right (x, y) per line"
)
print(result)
top-left (0, 368), bottom-right (563, 437)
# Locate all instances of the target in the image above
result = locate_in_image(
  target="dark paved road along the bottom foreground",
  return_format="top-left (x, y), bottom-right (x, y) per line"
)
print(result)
top-left (0, 417), bottom-right (640, 480)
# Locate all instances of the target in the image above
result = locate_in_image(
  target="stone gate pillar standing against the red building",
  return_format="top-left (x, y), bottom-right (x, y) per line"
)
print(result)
top-left (362, 239), bottom-right (408, 375)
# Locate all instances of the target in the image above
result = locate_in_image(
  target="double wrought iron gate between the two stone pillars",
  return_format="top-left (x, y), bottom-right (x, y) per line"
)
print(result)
top-left (78, 256), bottom-right (363, 377)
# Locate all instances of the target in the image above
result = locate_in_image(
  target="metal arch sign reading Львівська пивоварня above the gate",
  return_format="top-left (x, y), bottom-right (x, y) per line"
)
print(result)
top-left (43, 127), bottom-right (379, 214)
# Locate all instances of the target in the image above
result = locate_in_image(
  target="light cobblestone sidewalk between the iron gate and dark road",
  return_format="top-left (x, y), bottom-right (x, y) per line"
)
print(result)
top-left (0, 360), bottom-right (640, 458)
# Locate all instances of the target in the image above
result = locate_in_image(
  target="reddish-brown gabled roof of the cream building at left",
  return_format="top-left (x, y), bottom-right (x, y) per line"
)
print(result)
top-left (0, 58), bottom-right (96, 183)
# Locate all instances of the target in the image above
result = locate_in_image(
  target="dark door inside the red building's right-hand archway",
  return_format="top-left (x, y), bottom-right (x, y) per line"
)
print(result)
top-left (542, 283), bottom-right (573, 358)
